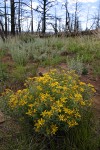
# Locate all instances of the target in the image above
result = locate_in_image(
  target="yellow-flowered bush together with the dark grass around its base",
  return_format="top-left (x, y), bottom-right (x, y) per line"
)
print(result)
top-left (0, 70), bottom-right (99, 150)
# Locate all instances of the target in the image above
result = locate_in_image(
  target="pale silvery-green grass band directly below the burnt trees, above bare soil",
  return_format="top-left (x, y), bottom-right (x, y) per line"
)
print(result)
top-left (0, 34), bottom-right (100, 75)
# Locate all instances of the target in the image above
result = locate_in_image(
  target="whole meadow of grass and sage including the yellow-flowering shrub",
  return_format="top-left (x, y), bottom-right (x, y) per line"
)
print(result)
top-left (0, 36), bottom-right (100, 150)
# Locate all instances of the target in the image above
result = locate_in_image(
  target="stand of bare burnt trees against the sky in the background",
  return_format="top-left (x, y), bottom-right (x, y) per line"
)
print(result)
top-left (0, 0), bottom-right (100, 37)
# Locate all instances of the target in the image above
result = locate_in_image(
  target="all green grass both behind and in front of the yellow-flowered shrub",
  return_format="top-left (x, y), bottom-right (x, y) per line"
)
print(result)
top-left (0, 35), bottom-right (100, 150)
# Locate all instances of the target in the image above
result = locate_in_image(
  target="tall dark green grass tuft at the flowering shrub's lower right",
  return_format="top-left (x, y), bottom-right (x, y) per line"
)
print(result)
top-left (64, 109), bottom-right (98, 150)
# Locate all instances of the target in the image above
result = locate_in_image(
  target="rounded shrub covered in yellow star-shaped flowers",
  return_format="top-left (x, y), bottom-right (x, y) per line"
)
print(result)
top-left (4, 70), bottom-right (95, 135)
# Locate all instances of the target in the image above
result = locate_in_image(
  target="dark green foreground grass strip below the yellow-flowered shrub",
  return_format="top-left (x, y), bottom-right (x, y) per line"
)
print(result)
top-left (0, 110), bottom-right (100, 150)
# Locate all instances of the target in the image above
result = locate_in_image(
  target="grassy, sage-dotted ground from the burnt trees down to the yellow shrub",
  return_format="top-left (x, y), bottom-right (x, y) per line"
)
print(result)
top-left (0, 34), bottom-right (100, 92)
